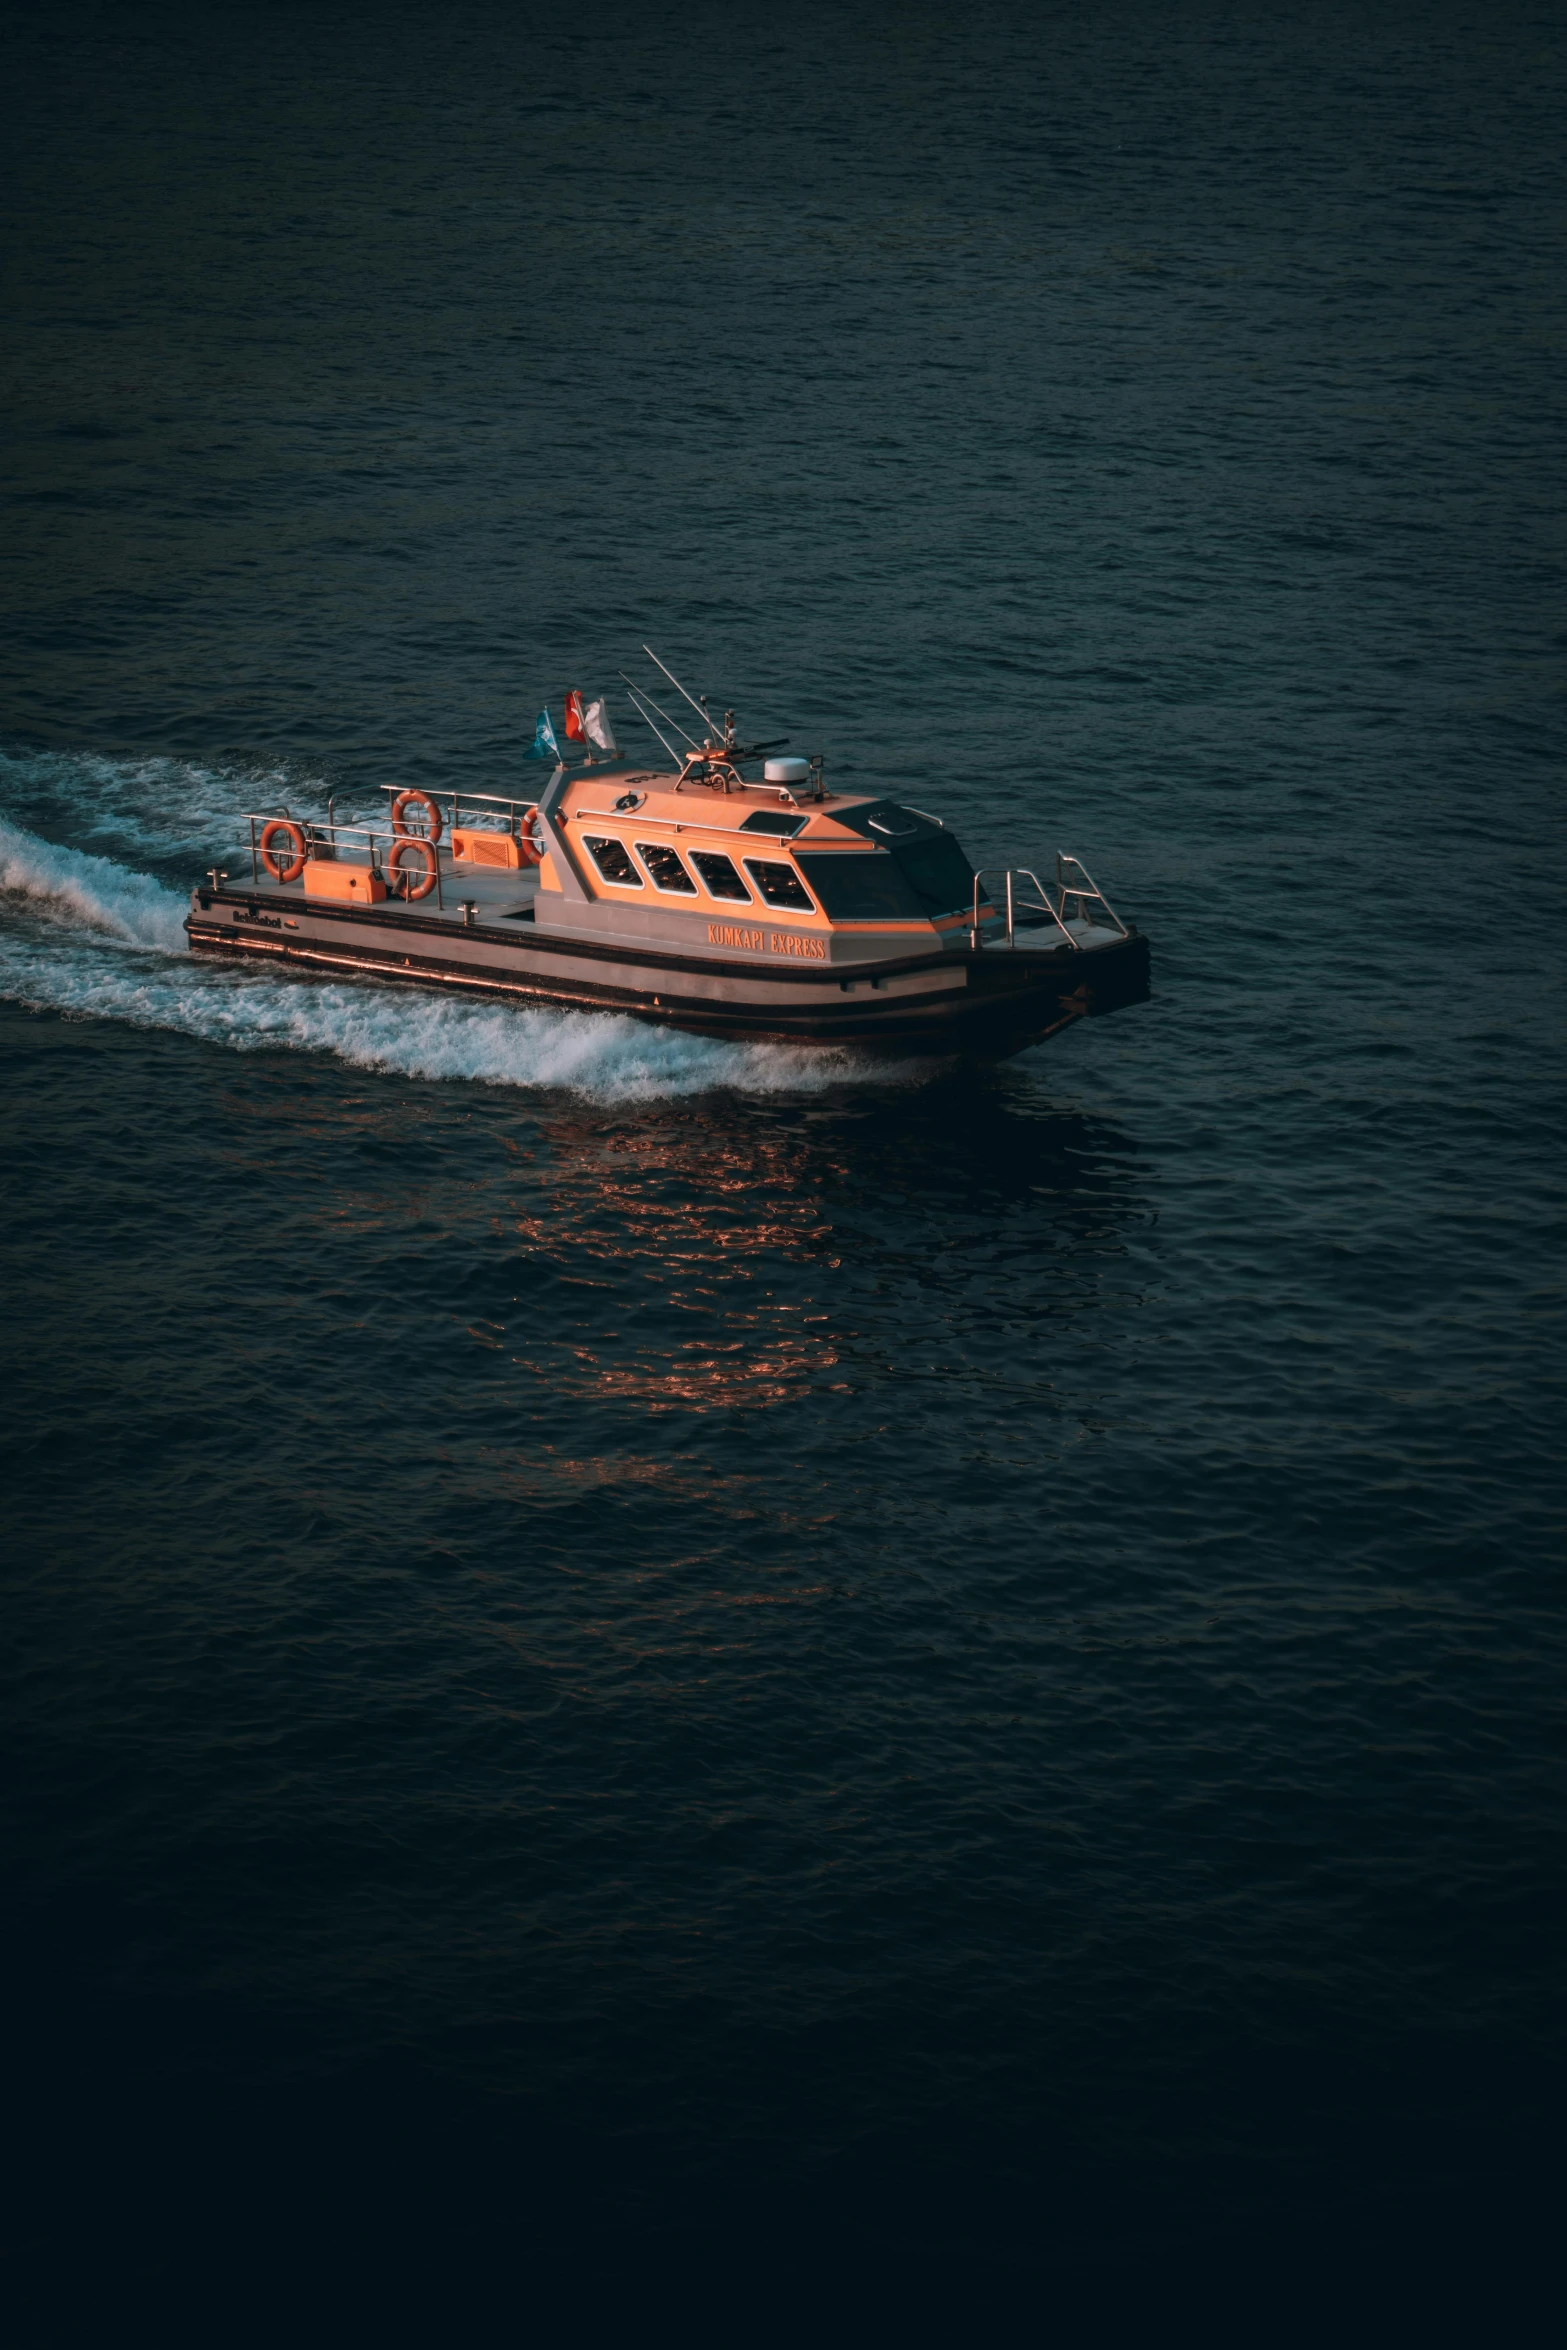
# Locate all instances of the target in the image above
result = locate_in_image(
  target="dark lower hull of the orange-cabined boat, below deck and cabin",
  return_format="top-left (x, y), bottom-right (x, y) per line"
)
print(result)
top-left (186, 888), bottom-right (1149, 1060)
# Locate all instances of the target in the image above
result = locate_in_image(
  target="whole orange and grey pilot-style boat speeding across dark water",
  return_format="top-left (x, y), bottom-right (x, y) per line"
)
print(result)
top-left (186, 653), bottom-right (1149, 1060)
